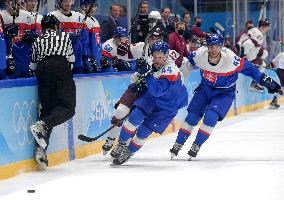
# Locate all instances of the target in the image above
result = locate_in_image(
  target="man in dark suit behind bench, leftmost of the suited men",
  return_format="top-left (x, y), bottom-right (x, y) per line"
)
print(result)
top-left (101, 4), bottom-right (121, 42)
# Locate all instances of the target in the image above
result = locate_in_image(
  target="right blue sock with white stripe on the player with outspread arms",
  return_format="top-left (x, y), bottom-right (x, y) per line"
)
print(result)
top-left (194, 110), bottom-right (219, 146)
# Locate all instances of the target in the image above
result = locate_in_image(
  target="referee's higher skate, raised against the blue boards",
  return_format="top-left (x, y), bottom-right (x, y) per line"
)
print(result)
top-left (30, 121), bottom-right (47, 149)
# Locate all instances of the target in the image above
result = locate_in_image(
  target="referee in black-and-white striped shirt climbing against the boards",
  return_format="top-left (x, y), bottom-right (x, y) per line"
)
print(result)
top-left (30, 15), bottom-right (76, 170)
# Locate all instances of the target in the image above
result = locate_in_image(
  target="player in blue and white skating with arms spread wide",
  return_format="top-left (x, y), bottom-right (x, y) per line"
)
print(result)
top-left (170, 34), bottom-right (282, 160)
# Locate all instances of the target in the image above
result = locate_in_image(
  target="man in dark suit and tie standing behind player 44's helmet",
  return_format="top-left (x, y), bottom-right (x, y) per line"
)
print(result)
top-left (159, 7), bottom-right (175, 42)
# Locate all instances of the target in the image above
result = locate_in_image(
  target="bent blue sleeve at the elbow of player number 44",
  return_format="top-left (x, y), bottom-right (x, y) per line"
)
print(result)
top-left (146, 76), bottom-right (171, 97)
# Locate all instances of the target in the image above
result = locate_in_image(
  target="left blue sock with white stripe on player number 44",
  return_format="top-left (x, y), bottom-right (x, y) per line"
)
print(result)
top-left (119, 108), bottom-right (145, 143)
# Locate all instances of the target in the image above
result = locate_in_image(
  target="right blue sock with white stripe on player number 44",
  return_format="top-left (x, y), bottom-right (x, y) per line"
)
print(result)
top-left (128, 123), bottom-right (152, 154)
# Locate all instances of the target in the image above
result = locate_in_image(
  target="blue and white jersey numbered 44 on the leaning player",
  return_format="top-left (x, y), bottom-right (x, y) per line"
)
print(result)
top-left (134, 62), bottom-right (188, 113)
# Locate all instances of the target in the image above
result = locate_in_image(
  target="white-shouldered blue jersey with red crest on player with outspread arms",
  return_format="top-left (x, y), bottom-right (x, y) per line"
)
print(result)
top-left (188, 47), bottom-right (262, 88)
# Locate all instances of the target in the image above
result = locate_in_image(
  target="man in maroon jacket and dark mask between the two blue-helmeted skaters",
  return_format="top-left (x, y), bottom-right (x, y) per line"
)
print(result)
top-left (169, 22), bottom-right (188, 67)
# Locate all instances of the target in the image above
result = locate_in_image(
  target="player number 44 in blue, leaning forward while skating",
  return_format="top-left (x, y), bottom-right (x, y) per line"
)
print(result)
top-left (111, 42), bottom-right (188, 165)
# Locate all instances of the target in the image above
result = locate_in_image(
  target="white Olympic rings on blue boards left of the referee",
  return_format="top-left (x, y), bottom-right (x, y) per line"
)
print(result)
top-left (13, 100), bottom-right (37, 146)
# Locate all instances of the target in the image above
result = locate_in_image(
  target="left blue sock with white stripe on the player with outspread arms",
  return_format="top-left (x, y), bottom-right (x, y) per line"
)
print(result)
top-left (176, 113), bottom-right (202, 145)
